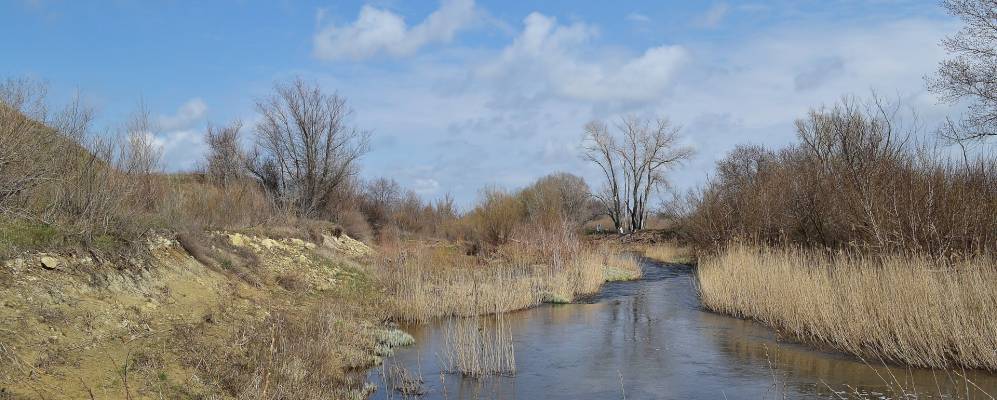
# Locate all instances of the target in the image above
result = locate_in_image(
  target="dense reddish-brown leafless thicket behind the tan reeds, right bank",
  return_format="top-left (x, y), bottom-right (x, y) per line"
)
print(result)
top-left (683, 95), bottom-right (997, 253)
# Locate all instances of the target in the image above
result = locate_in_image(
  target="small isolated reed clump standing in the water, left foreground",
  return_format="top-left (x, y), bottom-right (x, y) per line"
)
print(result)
top-left (444, 314), bottom-right (516, 377)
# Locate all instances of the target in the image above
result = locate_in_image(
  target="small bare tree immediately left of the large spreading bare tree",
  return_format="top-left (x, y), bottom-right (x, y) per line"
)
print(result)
top-left (204, 121), bottom-right (246, 187)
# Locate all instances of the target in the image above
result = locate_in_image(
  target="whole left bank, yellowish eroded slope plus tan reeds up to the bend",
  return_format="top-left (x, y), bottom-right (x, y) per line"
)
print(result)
top-left (0, 228), bottom-right (640, 399)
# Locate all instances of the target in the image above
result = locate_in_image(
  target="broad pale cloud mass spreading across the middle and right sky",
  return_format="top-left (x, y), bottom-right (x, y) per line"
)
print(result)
top-left (302, 9), bottom-right (956, 205)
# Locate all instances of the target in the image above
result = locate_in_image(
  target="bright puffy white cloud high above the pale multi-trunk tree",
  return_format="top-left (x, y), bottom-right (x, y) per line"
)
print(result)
top-left (477, 12), bottom-right (689, 102)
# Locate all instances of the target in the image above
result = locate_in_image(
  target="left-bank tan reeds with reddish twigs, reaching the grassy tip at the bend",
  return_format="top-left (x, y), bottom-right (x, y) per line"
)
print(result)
top-left (371, 220), bottom-right (640, 322)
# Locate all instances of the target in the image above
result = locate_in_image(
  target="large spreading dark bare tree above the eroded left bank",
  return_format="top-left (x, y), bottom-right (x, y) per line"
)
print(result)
top-left (249, 79), bottom-right (370, 216)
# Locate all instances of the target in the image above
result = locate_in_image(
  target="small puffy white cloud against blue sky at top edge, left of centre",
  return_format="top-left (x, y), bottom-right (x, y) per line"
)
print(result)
top-left (313, 0), bottom-right (476, 60)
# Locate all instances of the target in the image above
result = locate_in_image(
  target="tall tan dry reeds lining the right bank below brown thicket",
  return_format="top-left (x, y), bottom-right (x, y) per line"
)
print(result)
top-left (697, 244), bottom-right (997, 371)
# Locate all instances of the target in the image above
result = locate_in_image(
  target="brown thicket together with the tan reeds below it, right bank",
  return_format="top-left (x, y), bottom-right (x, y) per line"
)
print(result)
top-left (680, 93), bottom-right (997, 371)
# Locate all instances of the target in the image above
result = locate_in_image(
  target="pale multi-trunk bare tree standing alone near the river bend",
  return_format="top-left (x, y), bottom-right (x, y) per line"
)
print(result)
top-left (585, 116), bottom-right (692, 232)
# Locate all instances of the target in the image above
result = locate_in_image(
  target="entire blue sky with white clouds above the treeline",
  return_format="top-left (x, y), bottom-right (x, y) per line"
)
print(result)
top-left (0, 0), bottom-right (959, 205)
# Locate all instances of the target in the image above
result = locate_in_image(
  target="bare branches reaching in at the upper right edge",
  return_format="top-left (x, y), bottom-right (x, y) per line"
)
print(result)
top-left (928, 0), bottom-right (997, 142)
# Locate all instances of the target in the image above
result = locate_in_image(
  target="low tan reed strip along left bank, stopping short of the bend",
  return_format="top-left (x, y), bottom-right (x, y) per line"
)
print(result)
top-left (376, 241), bottom-right (605, 322)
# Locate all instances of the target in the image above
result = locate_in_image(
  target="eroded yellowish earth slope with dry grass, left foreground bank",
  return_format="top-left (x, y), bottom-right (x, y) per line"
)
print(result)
top-left (0, 230), bottom-right (410, 399)
